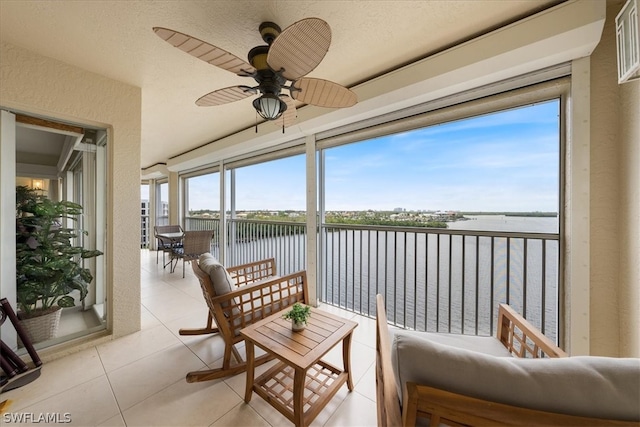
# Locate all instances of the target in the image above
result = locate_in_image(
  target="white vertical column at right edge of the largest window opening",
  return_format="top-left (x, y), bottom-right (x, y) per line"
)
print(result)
top-left (564, 57), bottom-right (591, 356)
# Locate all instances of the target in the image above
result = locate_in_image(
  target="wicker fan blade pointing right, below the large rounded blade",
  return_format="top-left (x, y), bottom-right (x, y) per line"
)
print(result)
top-left (291, 77), bottom-right (358, 108)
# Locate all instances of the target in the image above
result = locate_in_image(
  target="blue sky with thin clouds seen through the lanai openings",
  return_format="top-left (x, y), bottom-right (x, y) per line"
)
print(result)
top-left (150, 101), bottom-right (559, 212)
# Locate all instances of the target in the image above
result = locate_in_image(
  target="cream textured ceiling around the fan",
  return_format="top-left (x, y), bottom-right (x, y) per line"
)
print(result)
top-left (0, 0), bottom-right (558, 168)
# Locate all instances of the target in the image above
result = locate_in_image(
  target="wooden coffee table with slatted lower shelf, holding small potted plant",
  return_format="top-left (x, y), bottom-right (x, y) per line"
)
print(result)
top-left (240, 307), bottom-right (358, 426)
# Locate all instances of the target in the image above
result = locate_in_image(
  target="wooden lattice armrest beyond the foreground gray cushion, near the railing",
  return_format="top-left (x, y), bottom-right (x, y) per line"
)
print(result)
top-left (498, 304), bottom-right (568, 358)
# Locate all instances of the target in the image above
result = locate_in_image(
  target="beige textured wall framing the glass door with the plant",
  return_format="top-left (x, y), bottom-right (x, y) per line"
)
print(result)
top-left (0, 43), bottom-right (141, 351)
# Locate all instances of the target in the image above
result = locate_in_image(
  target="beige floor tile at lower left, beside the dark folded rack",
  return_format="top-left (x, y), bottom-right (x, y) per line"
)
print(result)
top-left (2, 348), bottom-right (105, 411)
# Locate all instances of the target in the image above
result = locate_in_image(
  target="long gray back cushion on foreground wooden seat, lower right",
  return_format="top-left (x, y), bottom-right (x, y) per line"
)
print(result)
top-left (391, 334), bottom-right (640, 421)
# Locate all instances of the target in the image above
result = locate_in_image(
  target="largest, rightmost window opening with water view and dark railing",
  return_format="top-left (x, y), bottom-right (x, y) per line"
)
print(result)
top-left (318, 79), bottom-right (567, 340)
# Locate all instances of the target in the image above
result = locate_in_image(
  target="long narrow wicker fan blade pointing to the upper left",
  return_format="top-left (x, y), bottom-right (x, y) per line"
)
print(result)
top-left (153, 27), bottom-right (256, 76)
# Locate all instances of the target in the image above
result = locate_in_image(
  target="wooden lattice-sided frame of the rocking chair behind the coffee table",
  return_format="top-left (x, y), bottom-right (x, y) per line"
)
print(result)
top-left (179, 254), bottom-right (308, 382)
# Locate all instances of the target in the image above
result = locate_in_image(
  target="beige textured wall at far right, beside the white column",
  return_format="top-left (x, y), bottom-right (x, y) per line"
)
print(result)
top-left (590, 1), bottom-right (640, 357)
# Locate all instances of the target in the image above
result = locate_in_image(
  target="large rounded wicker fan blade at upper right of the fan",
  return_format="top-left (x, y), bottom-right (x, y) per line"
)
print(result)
top-left (267, 18), bottom-right (331, 80)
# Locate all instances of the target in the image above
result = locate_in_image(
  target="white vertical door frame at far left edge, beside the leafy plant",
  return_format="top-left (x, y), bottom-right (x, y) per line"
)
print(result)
top-left (0, 110), bottom-right (18, 350)
